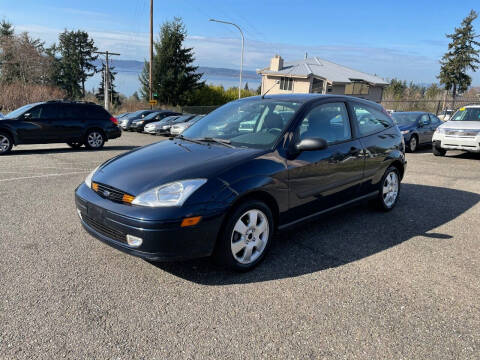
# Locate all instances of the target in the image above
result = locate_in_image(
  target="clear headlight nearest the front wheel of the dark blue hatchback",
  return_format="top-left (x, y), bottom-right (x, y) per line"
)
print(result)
top-left (132, 179), bottom-right (207, 207)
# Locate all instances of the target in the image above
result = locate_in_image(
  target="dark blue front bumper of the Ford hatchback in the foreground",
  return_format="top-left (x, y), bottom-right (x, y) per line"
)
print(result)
top-left (75, 184), bottom-right (224, 261)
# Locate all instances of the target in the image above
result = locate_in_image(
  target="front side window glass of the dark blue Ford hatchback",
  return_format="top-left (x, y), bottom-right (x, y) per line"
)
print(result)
top-left (299, 102), bottom-right (352, 144)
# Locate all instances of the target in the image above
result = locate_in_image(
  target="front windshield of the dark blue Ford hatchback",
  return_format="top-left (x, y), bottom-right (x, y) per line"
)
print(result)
top-left (183, 97), bottom-right (302, 149)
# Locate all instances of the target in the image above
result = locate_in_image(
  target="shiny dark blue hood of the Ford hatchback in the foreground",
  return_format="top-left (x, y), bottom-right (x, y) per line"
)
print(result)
top-left (93, 139), bottom-right (265, 196)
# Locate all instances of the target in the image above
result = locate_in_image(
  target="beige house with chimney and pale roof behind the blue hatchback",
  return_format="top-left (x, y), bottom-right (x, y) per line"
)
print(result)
top-left (257, 55), bottom-right (388, 102)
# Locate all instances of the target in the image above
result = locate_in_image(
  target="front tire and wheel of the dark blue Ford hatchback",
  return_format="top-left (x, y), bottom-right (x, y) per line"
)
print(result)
top-left (213, 200), bottom-right (275, 272)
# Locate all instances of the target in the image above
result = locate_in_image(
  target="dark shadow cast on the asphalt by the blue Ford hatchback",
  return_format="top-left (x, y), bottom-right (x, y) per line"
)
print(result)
top-left (150, 184), bottom-right (480, 286)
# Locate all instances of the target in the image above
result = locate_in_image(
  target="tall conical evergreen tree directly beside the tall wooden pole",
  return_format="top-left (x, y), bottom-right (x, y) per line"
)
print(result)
top-left (139, 18), bottom-right (203, 106)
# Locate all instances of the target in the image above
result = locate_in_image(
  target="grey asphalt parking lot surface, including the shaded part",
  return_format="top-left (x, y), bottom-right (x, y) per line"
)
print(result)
top-left (0, 133), bottom-right (480, 359)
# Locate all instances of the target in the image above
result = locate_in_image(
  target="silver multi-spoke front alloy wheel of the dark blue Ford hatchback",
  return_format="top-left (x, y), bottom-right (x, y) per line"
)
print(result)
top-left (231, 209), bottom-right (270, 265)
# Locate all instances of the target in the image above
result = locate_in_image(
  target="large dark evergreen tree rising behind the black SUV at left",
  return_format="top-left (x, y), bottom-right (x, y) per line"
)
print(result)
top-left (48, 30), bottom-right (98, 98)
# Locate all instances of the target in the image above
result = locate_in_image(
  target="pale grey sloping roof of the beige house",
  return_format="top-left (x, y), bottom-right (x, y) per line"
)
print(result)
top-left (258, 57), bottom-right (388, 85)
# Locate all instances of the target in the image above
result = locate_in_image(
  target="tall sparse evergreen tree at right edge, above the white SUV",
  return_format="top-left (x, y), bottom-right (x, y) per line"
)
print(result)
top-left (438, 10), bottom-right (480, 99)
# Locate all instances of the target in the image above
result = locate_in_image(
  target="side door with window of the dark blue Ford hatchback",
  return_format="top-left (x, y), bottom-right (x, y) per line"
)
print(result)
top-left (287, 101), bottom-right (364, 219)
